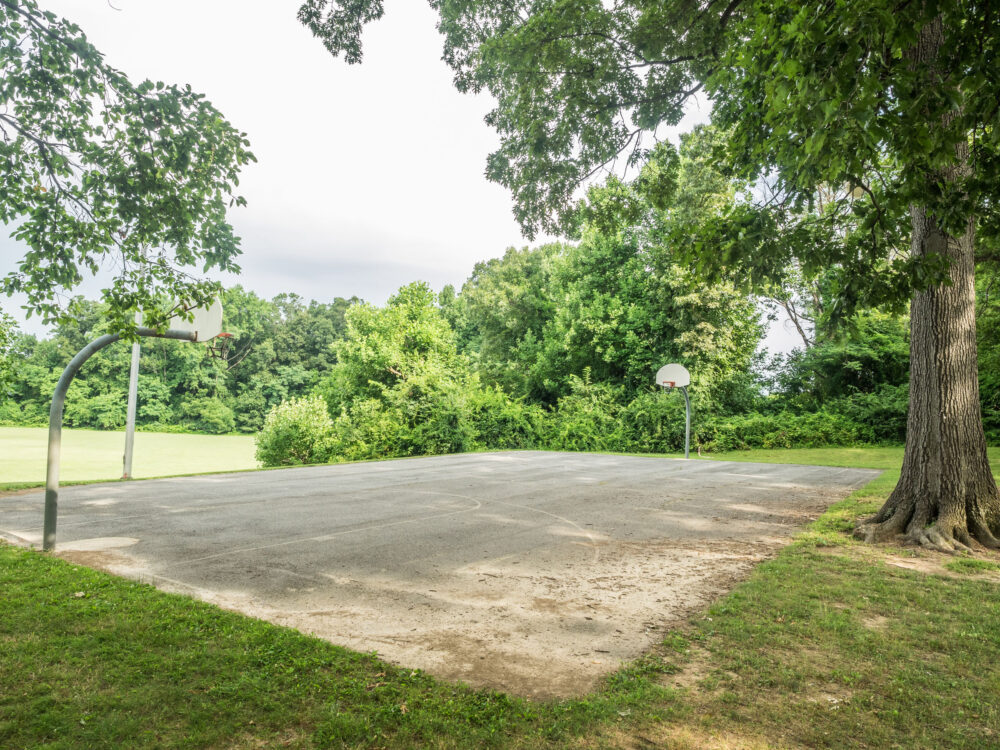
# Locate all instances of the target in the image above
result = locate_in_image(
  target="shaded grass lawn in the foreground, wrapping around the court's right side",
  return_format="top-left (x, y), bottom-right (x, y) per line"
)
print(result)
top-left (0, 449), bottom-right (1000, 750)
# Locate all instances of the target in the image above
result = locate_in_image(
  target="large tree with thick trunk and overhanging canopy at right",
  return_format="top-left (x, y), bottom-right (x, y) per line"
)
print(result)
top-left (300, 0), bottom-right (1000, 551)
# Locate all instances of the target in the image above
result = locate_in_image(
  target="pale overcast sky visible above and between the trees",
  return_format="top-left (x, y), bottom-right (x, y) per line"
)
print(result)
top-left (0, 0), bottom-right (795, 350)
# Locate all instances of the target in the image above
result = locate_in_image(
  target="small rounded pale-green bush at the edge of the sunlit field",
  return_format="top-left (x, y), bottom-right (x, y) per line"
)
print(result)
top-left (256, 396), bottom-right (334, 466)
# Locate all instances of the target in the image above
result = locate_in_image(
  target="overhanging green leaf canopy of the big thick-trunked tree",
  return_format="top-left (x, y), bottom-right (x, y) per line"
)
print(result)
top-left (307, 0), bottom-right (1000, 308)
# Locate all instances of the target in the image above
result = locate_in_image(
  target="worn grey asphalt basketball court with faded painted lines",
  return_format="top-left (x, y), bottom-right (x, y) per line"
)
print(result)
top-left (0, 451), bottom-right (879, 697)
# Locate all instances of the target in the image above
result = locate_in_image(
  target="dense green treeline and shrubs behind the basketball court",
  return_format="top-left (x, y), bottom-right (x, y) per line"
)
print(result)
top-left (0, 128), bottom-right (1000, 464)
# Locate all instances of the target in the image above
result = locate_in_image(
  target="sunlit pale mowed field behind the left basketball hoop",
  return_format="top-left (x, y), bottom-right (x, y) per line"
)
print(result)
top-left (0, 427), bottom-right (257, 489)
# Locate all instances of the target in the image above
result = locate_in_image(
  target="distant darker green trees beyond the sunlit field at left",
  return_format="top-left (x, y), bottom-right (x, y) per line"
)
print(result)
top-left (0, 286), bottom-right (357, 434)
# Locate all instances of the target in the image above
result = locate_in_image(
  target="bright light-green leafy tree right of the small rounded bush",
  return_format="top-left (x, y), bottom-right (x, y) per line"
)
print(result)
top-left (320, 283), bottom-right (540, 459)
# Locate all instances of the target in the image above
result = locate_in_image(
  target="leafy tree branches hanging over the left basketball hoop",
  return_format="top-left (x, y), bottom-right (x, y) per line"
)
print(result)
top-left (0, 0), bottom-right (253, 332)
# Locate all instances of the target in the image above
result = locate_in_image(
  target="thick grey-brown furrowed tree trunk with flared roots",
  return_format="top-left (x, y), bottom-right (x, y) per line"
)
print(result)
top-left (858, 208), bottom-right (1000, 551)
